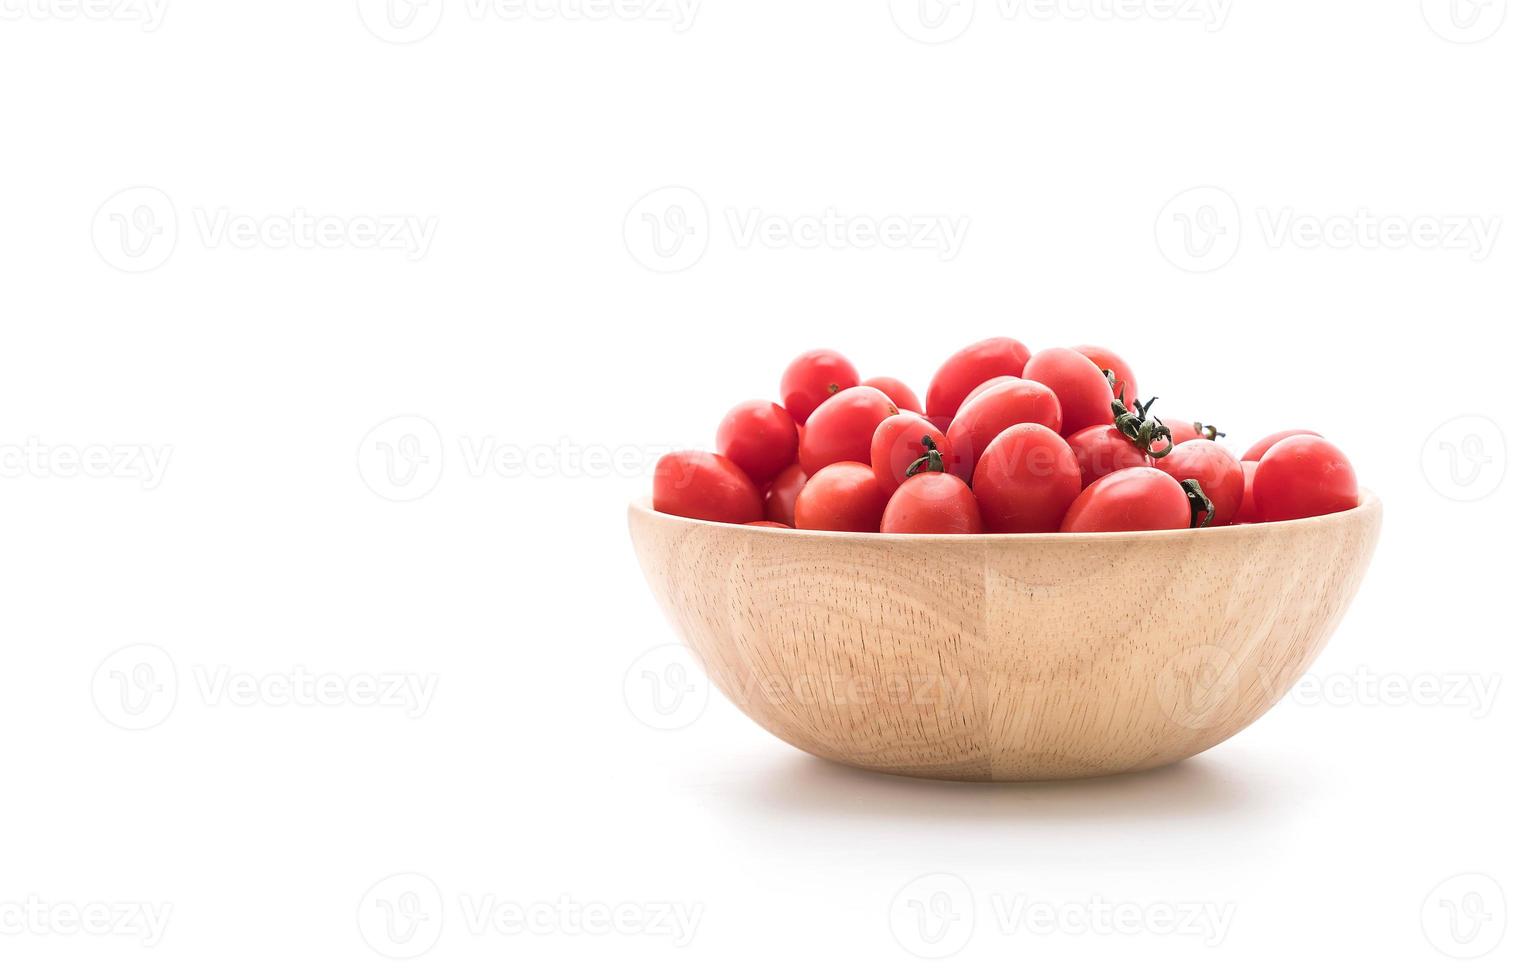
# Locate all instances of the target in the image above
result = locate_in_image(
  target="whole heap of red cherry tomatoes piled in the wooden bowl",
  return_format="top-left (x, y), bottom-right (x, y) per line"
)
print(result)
top-left (653, 337), bottom-right (1358, 534)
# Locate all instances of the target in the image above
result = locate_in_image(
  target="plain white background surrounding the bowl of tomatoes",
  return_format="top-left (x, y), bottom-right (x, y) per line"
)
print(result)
top-left (0, 0), bottom-right (1516, 977)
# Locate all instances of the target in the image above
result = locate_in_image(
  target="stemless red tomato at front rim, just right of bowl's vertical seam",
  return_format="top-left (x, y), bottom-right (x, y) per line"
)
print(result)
top-left (973, 422), bottom-right (1079, 532)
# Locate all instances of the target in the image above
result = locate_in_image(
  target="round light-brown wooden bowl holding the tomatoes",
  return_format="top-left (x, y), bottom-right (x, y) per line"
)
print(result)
top-left (631, 493), bottom-right (1381, 780)
